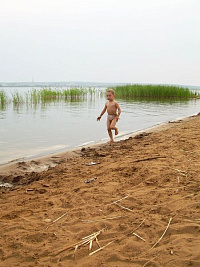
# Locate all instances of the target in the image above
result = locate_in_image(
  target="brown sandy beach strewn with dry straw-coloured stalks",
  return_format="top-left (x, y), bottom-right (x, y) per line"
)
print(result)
top-left (0, 116), bottom-right (200, 267)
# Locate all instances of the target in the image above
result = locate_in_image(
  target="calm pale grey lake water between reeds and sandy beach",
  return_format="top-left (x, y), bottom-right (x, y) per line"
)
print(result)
top-left (0, 87), bottom-right (200, 164)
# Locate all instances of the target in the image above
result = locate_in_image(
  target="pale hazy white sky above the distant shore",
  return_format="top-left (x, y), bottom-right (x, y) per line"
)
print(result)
top-left (0, 0), bottom-right (200, 86)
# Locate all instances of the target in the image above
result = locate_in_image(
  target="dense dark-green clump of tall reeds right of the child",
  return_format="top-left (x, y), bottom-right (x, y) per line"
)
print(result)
top-left (113, 84), bottom-right (198, 99)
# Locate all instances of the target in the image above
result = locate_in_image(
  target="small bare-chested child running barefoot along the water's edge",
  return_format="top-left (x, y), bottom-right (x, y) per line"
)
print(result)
top-left (97, 89), bottom-right (121, 143)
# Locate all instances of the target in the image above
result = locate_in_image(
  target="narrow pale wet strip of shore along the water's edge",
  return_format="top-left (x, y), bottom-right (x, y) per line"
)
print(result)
top-left (0, 114), bottom-right (198, 175)
